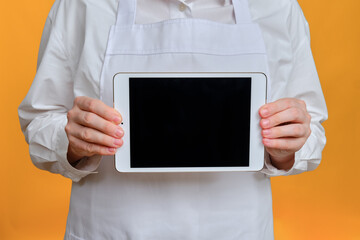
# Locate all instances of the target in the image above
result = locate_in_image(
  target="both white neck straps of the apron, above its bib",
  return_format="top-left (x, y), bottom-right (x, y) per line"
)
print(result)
top-left (116, 0), bottom-right (252, 26)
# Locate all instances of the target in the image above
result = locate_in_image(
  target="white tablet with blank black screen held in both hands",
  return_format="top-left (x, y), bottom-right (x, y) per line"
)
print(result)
top-left (114, 73), bottom-right (267, 172)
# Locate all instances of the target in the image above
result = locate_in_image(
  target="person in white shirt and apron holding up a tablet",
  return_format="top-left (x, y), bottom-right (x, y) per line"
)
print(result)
top-left (19, 0), bottom-right (327, 240)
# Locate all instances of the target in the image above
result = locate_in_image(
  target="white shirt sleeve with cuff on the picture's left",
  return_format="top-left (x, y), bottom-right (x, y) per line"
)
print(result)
top-left (18, 0), bottom-right (101, 181)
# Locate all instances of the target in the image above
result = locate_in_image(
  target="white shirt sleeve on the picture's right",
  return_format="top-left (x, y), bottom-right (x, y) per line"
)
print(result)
top-left (262, 0), bottom-right (328, 176)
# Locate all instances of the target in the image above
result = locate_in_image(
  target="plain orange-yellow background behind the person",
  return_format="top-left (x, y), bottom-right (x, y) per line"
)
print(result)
top-left (0, 0), bottom-right (360, 240)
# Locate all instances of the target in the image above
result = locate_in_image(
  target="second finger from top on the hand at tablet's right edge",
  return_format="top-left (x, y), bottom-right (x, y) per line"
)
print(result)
top-left (260, 108), bottom-right (307, 129)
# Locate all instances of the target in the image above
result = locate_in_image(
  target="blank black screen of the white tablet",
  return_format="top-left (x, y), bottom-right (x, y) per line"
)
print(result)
top-left (129, 77), bottom-right (251, 168)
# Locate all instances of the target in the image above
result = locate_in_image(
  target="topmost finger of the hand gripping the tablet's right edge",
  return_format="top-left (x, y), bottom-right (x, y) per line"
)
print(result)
top-left (259, 98), bottom-right (306, 118)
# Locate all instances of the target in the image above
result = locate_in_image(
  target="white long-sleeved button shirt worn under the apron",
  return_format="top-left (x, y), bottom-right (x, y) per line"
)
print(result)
top-left (19, 0), bottom-right (327, 239)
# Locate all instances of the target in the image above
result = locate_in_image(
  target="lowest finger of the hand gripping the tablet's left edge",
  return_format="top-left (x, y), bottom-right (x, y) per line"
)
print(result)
top-left (69, 136), bottom-right (116, 157)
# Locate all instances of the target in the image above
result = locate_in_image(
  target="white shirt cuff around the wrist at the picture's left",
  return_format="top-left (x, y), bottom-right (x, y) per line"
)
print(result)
top-left (54, 116), bottom-right (102, 182)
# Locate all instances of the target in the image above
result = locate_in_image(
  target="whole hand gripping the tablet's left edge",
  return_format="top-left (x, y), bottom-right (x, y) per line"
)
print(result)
top-left (65, 96), bottom-right (124, 164)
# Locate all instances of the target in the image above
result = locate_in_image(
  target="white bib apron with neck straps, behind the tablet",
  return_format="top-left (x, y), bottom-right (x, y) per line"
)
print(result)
top-left (65, 0), bottom-right (273, 240)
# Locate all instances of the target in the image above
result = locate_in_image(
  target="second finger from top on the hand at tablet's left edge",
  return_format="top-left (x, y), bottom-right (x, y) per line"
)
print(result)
top-left (74, 111), bottom-right (124, 138)
